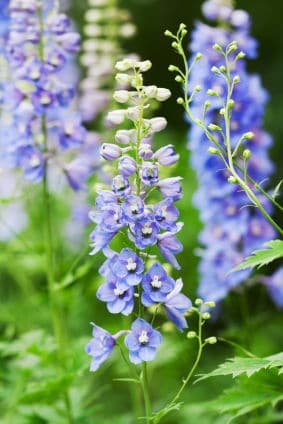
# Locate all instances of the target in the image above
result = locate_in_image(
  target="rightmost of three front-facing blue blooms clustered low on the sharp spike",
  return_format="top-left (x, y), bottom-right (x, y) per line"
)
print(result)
top-left (142, 262), bottom-right (175, 306)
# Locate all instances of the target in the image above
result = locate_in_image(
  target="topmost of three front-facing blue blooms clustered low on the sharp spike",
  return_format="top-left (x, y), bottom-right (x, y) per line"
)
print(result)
top-left (109, 248), bottom-right (144, 286)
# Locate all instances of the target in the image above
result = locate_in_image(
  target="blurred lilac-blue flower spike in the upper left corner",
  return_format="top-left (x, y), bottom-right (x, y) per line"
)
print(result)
top-left (1, 0), bottom-right (94, 190)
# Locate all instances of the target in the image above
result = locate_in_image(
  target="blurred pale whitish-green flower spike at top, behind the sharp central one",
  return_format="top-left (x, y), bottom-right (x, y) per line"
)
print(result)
top-left (80, 0), bottom-right (135, 122)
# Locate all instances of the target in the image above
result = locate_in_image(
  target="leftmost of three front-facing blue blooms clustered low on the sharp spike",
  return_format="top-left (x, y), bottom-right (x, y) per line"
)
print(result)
top-left (97, 281), bottom-right (134, 315)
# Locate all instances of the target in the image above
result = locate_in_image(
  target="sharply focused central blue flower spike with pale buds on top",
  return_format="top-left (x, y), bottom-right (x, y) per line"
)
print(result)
top-left (86, 59), bottom-right (191, 369)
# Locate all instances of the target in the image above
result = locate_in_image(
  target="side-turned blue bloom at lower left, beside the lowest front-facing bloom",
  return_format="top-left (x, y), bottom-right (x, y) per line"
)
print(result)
top-left (85, 323), bottom-right (116, 371)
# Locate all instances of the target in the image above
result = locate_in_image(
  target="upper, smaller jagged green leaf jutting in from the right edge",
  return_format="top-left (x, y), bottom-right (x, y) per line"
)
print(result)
top-left (231, 240), bottom-right (283, 272)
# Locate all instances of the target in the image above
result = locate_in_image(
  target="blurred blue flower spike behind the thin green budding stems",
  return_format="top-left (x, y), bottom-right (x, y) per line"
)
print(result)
top-left (189, 0), bottom-right (274, 301)
